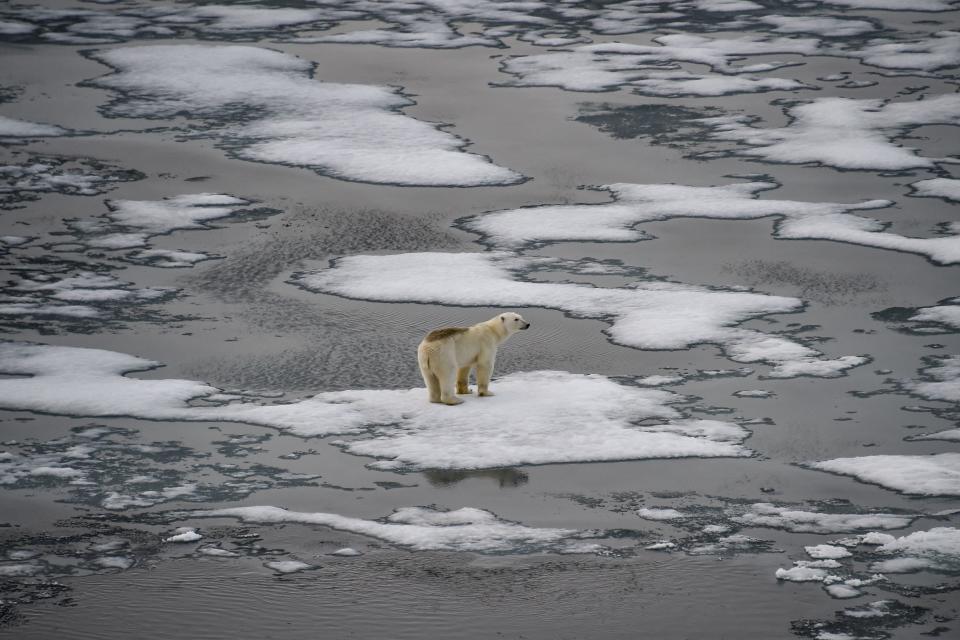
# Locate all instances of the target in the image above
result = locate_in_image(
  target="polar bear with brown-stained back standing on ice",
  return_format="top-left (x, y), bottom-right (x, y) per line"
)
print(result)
top-left (417, 313), bottom-right (530, 405)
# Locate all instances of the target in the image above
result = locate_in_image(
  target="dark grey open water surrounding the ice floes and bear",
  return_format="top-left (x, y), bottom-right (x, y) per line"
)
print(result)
top-left (0, 2), bottom-right (960, 639)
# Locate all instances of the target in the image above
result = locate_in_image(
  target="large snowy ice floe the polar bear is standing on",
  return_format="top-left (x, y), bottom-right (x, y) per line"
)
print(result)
top-left (0, 343), bottom-right (751, 470)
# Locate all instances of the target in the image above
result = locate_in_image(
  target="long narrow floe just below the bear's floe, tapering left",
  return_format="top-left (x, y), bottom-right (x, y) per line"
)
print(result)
top-left (190, 506), bottom-right (599, 553)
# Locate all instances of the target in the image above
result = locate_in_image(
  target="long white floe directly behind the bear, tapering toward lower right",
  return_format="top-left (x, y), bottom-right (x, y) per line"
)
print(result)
top-left (294, 252), bottom-right (867, 377)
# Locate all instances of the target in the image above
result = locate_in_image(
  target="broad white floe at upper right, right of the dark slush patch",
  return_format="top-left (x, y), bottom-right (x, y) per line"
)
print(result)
top-left (703, 94), bottom-right (960, 171)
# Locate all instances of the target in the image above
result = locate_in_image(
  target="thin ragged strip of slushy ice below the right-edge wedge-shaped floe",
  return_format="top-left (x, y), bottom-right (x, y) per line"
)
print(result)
top-left (732, 502), bottom-right (916, 533)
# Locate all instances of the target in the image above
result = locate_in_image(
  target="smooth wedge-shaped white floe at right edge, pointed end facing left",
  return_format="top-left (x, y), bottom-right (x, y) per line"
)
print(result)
top-left (806, 453), bottom-right (960, 495)
